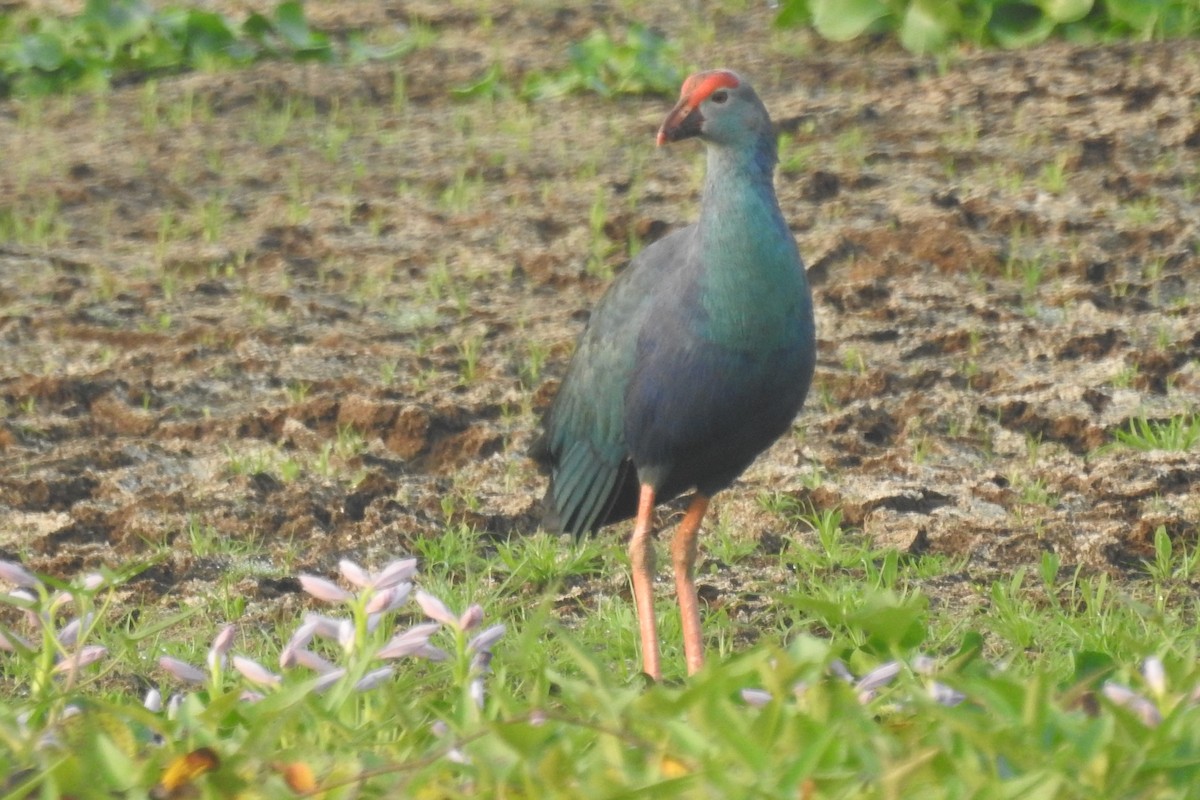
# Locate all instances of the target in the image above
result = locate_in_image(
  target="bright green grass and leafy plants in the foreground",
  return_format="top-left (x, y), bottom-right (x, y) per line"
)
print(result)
top-left (0, 527), bottom-right (1200, 798)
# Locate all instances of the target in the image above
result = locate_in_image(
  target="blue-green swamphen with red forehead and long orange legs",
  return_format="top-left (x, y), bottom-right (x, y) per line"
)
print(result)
top-left (530, 70), bottom-right (816, 680)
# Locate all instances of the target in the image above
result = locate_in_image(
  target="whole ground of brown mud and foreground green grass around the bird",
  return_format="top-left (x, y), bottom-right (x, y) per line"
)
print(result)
top-left (0, 4), bottom-right (1200, 798)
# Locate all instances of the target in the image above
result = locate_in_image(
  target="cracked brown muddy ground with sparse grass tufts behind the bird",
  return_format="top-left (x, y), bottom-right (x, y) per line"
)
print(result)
top-left (0, 2), bottom-right (1200, 657)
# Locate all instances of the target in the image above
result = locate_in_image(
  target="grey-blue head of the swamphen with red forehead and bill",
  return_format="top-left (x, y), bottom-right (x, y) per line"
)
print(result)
top-left (658, 70), bottom-right (770, 146)
